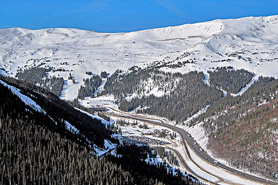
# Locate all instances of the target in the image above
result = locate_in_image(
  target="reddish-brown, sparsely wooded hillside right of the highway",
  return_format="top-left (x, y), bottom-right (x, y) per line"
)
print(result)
top-left (191, 77), bottom-right (278, 179)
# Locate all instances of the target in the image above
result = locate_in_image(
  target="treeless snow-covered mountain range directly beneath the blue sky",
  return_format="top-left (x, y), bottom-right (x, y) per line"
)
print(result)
top-left (0, 15), bottom-right (278, 99)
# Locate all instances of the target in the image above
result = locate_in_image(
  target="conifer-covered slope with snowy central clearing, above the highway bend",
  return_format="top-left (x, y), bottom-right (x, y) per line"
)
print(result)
top-left (99, 67), bottom-right (253, 122)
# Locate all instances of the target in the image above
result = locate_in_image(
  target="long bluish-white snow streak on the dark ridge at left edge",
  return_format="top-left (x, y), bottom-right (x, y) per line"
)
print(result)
top-left (0, 80), bottom-right (46, 114)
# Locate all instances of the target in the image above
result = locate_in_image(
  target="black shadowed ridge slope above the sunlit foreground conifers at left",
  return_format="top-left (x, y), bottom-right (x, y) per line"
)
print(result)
top-left (0, 76), bottom-right (112, 147)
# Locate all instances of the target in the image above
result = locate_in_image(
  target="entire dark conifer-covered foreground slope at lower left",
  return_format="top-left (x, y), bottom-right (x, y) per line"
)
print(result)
top-left (0, 77), bottom-right (200, 185)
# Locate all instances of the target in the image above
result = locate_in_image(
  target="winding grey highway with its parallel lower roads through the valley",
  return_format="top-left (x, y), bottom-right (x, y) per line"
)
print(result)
top-left (107, 107), bottom-right (278, 185)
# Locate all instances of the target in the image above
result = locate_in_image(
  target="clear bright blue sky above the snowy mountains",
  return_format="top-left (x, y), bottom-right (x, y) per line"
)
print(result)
top-left (0, 0), bottom-right (278, 32)
